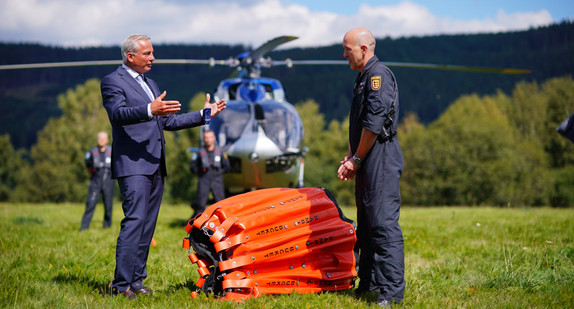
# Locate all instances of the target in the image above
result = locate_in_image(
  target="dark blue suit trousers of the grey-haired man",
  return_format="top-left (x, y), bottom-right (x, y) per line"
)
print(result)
top-left (112, 169), bottom-right (164, 292)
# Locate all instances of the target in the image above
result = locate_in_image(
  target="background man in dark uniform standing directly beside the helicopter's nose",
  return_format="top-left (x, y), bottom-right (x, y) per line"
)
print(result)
top-left (189, 130), bottom-right (229, 217)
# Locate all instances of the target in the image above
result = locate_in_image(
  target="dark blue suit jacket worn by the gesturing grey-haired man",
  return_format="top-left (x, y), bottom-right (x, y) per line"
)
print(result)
top-left (101, 66), bottom-right (204, 178)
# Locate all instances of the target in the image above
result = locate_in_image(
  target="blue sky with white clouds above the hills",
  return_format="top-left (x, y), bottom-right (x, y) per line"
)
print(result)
top-left (0, 0), bottom-right (574, 48)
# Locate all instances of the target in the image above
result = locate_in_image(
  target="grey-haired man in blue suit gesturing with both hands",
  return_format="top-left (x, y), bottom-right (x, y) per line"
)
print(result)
top-left (101, 34), bottom-right (226, 299)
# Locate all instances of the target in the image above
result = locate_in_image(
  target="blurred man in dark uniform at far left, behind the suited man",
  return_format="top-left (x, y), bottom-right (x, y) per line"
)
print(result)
top-left (80, 132), bottom-right (114, 230)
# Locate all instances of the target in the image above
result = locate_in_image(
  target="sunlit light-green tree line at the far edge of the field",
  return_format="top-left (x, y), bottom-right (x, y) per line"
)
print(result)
top-left (0, 76), bottom-right (574, 207)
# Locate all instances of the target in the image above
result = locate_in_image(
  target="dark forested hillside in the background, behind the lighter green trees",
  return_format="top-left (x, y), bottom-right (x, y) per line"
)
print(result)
top-left (0, 21), bottom-right (574, 149)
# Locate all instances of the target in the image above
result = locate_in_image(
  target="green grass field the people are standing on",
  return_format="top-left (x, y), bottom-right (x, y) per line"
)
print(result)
top-left (0, 203), bottom-right (574, 308)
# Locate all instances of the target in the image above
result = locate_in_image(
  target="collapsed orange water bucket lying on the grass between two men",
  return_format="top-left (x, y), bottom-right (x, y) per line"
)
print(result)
top-left (183, 188), bottom-right (357, 301)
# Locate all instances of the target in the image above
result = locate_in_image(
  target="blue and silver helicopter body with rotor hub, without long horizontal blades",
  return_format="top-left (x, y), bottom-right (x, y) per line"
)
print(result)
top-left (190, 36), bottom-right (308, 193)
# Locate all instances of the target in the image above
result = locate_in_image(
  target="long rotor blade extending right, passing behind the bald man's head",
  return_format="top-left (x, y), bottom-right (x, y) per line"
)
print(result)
top-left (286, 59), bottom-right (532, 74)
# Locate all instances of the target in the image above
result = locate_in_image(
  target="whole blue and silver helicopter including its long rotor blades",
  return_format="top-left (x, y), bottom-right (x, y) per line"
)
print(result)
top-left (0, 36), bottom-right (530, 194)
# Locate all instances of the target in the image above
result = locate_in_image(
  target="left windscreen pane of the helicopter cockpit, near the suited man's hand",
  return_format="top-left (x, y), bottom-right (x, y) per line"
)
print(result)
top-left (209, 101), bottom-right (250, 148)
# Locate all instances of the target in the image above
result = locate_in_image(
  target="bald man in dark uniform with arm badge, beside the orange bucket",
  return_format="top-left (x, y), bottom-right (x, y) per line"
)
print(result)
top-left (338, 28), bottom-right (405, 307)
